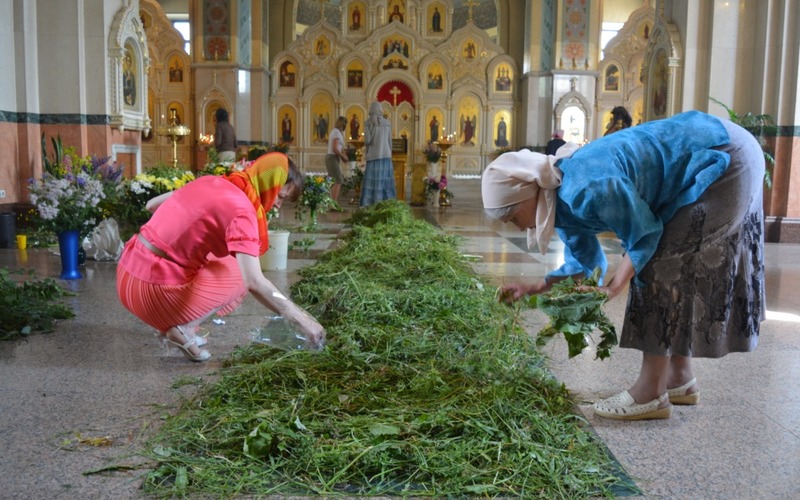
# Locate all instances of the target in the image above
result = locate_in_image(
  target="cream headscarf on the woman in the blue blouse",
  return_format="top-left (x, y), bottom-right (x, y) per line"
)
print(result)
top-left (481, 142), bottom-right (578, 255)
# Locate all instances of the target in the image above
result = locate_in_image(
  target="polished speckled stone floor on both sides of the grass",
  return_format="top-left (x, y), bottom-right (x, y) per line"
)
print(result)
top-left (0, 178), bottom-right (800, 499)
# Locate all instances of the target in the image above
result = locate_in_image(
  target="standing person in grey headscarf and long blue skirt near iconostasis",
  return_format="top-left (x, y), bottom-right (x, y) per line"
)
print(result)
top-left (358, 102), bottom-right (397, 207)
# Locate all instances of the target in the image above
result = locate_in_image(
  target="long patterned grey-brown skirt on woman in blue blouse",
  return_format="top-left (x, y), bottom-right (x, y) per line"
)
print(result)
top-left (620, 120), bottom-right (765, 358)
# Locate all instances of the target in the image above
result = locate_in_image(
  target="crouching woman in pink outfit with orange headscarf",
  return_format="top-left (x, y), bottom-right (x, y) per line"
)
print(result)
top-left (117, 153), bottom-right (325, 361)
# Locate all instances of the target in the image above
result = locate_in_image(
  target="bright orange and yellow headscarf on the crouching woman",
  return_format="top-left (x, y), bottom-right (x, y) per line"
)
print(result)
top-left (226, 153), bottom-right (289, 254)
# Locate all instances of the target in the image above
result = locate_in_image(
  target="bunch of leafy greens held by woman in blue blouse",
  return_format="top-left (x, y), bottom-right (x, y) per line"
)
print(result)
top-left (528, 269), bottom-right (617, 359)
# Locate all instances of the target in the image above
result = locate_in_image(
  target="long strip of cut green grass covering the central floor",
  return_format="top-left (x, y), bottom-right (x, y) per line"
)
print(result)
top-left (146, 202), bottom-right (630, 498)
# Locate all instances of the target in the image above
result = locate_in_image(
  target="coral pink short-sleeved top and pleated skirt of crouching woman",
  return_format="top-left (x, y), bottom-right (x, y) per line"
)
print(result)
top-left (117, 176), bottom-right (259, 332)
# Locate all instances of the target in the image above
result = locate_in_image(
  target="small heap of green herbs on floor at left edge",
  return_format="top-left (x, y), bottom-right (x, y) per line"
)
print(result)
top-left (0, 267), bottom-right (75, 340)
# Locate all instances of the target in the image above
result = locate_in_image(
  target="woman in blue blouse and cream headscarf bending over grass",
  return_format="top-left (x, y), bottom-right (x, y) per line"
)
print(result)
top-left (481, 111), bottom-right (765, 420)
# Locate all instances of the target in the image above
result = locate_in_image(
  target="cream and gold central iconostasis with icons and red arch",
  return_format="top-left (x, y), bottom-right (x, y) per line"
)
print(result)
top-left (272, 0), bottom-right (521, 174)
